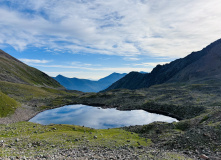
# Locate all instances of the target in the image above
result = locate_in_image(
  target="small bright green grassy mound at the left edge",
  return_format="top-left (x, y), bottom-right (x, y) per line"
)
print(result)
top-left (0, 91), bottom-right (20, 117)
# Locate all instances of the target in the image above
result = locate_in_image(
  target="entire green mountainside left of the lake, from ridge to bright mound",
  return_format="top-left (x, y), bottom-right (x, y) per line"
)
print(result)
top-left (0, 50), bottom-right (74, 117)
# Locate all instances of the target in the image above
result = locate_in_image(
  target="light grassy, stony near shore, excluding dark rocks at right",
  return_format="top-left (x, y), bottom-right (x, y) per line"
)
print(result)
top-left (0, 122), bottom-right (191, 160)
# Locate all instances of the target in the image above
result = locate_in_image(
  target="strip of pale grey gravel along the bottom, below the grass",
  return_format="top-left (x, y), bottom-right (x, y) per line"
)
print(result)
top-left (0, 147), bottom-right (194, 160)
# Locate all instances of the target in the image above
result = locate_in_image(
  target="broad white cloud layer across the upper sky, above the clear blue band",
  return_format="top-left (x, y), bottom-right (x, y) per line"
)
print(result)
top-left (0, 0), bottom-right (221, 58)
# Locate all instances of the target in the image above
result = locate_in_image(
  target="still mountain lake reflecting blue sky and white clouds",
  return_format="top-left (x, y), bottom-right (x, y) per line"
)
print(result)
top-left (30, 104), bottom-right (177, 129)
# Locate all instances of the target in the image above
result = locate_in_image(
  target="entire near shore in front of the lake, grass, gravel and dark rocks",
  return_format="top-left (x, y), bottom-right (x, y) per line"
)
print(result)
top-left (0, 109), bottom-right (221, 160)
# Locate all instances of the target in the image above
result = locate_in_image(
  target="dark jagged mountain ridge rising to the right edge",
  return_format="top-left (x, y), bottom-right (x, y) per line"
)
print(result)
top-left (106, 39), bottom-right (221, 90)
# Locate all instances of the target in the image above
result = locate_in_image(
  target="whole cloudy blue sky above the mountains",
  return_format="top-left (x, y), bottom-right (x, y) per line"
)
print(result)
top-left (0, 0), bottom-right (221, 79)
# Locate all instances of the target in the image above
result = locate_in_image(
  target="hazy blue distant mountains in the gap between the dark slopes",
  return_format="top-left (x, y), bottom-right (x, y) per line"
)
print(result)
top-left (53, 73), bottom-right (126, 92)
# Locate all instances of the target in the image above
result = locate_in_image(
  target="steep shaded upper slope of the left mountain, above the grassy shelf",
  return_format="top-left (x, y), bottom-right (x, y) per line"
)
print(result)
top-left (0, 50), bottom-right (63, 88)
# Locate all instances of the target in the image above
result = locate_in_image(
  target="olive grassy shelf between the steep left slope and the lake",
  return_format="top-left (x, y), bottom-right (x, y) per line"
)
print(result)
top-left (0, 81), bottom-right (82, 110)
